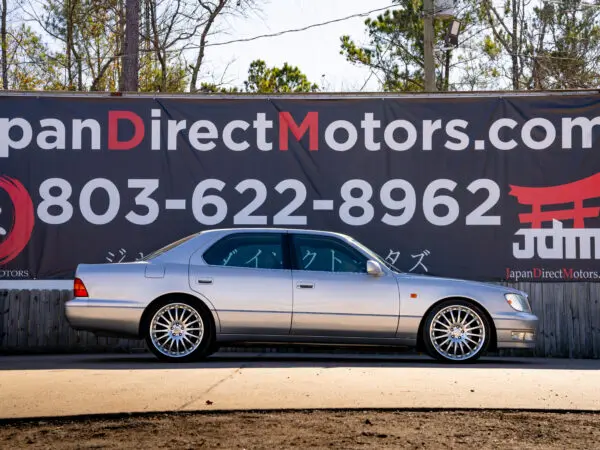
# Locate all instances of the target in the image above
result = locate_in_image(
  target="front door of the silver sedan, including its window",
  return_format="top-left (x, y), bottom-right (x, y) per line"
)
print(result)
top-left (291, 233), bottom-right (400, 338)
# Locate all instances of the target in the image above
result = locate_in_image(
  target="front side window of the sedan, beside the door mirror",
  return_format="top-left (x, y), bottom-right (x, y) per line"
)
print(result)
top-left (293, 235), bottom-right (367, 273)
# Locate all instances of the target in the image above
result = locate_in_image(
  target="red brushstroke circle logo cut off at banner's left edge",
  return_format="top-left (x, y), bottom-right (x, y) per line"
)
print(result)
top-left (0, 176), bottom-right (34, 266)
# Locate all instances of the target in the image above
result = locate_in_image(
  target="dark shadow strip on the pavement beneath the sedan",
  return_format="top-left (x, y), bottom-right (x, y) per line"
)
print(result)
top-left (0, 352), bottom-right (600, 371)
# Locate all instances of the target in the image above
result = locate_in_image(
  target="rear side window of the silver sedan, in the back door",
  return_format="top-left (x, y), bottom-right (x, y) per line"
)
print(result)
top-left (204, 233), bottom-right (284, 269)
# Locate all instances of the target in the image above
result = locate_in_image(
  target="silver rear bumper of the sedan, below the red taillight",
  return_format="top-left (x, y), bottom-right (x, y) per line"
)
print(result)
top-left (65, 298), bottom-right (144, 338)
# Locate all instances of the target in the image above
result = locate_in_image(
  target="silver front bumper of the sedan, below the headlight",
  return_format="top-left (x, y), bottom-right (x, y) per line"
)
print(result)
top-left (494, 312), bottom-right (538, 348)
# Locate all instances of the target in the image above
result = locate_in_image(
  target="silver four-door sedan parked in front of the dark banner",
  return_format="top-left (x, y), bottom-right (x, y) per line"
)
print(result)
top-left (66, 228), bottom-right (537, 363)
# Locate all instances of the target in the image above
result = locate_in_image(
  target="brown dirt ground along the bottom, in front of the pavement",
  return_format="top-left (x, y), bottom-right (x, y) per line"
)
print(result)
top-left (0, 411), bottom-right (600, 450)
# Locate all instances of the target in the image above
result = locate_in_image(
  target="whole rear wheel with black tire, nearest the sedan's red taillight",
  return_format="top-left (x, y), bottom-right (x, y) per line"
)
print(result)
top-left (143, 297), bottom-right (215, 363)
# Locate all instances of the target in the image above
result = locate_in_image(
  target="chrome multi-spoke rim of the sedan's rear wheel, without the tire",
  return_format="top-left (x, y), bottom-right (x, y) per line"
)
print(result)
top-left (149, 303), bottom-right (205, 358)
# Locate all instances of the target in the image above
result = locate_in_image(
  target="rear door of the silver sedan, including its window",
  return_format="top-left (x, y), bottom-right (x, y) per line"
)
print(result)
top-left (190, 233), bottom-right (292, 335)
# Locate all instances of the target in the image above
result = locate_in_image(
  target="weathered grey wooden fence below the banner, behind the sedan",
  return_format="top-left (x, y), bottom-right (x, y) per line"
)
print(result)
top-left (0, 283), bottom-right (600, 358)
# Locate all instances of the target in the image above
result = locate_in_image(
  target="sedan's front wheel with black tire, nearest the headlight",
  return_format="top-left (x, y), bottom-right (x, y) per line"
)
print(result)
top-left (423, 300), bottom-right (493, 363)
